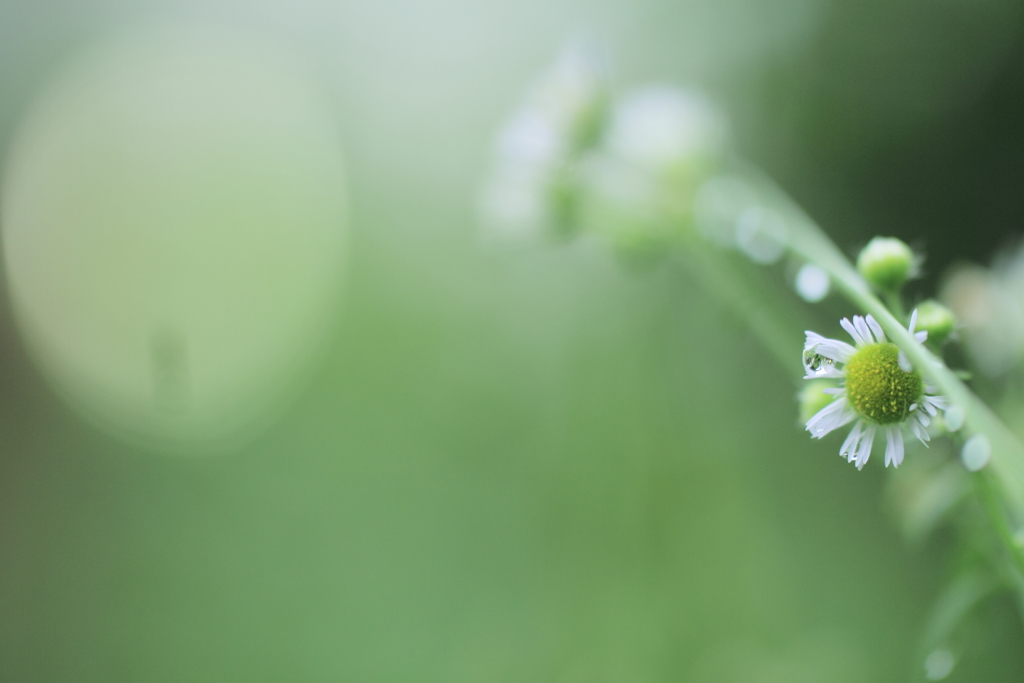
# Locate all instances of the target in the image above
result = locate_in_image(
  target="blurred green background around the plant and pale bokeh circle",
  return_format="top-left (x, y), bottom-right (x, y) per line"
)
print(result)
top-left (0, 0), bottom-right (1024, 683)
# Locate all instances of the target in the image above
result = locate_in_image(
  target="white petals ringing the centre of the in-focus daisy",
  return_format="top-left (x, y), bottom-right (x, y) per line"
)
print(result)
top-left (804, 311), bottom-right (946, 470)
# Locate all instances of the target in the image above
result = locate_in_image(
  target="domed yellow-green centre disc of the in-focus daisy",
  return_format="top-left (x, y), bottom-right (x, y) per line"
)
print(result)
top-left (846, 344), bottom-right (924, 425)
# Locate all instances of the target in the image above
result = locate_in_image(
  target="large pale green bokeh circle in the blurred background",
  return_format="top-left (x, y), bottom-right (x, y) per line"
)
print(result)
top-left (0, 30), bottom-right (347, 452)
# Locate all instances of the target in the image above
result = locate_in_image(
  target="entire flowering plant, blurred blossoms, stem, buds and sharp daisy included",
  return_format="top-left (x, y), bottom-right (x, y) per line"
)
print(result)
top-left (482, 41), bottom-right (1024, 667)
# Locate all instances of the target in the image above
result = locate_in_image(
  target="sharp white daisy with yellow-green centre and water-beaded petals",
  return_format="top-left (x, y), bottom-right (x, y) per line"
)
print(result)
top-left (804, 310), bottom-right (946, 470)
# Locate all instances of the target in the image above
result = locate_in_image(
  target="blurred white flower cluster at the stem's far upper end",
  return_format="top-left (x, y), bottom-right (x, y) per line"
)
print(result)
top-left (482, 45), bottom-right (729, 259)
